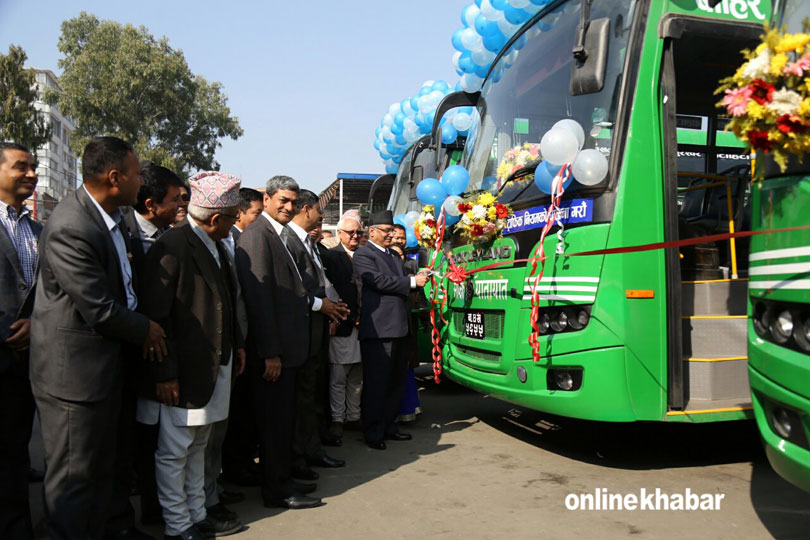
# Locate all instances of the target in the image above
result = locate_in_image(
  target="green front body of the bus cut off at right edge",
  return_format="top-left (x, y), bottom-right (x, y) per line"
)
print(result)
top-left (748, 175), bottom-right (810, 491)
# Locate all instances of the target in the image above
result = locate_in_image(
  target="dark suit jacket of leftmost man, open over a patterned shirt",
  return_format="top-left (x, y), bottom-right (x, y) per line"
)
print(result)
top-left (0, 213), bottom-right (42, 375)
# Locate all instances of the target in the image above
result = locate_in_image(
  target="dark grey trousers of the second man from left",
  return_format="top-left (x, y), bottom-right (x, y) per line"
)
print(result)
top-left (33, 380), bottom-right (121, 540)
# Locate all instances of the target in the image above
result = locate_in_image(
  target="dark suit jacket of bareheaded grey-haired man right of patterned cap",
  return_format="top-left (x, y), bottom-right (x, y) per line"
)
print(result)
top-left (236, 216), bottom-right (310, 367)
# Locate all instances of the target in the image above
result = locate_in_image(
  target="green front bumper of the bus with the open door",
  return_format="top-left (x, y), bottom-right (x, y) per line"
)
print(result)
top-left (445, 345), bottom-right (639, 422)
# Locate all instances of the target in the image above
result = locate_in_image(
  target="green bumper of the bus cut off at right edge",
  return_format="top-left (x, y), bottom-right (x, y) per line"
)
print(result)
top-left (748, 366), bottom-right (810, 491)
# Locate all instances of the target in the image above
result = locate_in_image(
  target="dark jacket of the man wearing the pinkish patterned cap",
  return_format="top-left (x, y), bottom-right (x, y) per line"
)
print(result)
top-left (139, 221), bottom-right (244, 409)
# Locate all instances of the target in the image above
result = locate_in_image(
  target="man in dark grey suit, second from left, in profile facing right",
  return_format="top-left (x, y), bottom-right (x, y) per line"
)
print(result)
top-left (30, 137), bottom-right (166, 539)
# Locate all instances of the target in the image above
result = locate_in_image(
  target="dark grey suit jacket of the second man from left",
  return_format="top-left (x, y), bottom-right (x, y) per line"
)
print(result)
top-left (31, 188), bottom-right (149, 402)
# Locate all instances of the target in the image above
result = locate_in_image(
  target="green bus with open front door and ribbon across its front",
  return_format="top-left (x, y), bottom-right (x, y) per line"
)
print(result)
top-left (426, 0), bottom-right (771, 422)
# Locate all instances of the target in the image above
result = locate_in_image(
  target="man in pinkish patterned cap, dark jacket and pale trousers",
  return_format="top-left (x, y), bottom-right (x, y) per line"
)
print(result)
top-left (138, 171), bottom-right (245, 540)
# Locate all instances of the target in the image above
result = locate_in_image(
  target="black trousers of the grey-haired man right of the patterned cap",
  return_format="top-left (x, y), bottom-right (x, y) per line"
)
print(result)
top-left (250, 361), bottom-right (297, 502)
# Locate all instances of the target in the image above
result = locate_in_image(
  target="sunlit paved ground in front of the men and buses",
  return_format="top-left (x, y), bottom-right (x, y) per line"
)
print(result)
top-left (31, 366), bottom-right (810, 540)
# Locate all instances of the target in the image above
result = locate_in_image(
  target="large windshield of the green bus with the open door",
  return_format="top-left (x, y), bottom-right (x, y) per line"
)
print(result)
top-left (465, 0), bottom-right (636, 203)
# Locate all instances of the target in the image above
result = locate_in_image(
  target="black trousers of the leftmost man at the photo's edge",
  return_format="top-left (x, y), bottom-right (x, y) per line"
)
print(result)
top-left (0, 360), bottom-right (34, 540)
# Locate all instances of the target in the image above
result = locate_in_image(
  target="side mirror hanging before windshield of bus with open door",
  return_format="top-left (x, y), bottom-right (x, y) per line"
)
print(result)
top-left (569, 17), bottom-right (610, 96)
